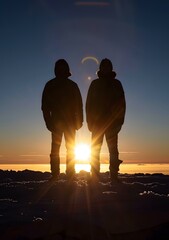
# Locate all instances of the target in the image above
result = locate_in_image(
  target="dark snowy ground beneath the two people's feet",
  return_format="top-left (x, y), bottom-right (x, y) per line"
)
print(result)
top-left (0, 170), bottom-right (169, 240)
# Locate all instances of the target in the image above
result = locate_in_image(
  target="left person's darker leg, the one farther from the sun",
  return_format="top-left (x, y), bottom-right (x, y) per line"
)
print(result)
top-left (50, 131), bottom-right (63, 177)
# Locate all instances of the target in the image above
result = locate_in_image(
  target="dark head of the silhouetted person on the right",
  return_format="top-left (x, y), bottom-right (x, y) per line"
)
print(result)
top-left (97, 58), bottom-right (116, 77)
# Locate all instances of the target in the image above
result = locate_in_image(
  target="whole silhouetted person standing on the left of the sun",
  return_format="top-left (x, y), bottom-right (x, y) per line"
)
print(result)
top-left (42, 59), bottom-right (83, 180)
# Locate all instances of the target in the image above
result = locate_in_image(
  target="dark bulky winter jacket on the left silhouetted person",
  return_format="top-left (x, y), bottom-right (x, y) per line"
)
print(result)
top-left (41, 78), bottom-right (83, 131)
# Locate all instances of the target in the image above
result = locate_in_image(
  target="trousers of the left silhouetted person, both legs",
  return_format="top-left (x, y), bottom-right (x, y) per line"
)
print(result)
top-left (50, 128), bottom-right (75, 175)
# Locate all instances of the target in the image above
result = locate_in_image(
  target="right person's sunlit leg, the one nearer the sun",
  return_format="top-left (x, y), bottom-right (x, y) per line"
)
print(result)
top-left (91, 129), bottom-right (104, 178)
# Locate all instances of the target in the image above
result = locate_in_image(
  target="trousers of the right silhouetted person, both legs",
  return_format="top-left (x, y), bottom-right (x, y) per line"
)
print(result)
top-left (91, 127), bottom-right (120, 174)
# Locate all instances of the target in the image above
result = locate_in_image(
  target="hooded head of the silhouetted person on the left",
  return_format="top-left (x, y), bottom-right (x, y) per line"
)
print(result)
top-left (54, 59), bottom-right (71, 78)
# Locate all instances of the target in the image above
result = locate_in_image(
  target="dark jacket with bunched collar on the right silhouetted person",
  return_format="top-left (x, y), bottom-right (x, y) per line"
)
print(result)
top-left (86, 71), bottom-right (126, 131)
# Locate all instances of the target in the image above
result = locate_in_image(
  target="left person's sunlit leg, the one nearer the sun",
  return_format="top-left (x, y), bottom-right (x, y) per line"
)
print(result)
top-left (64, 128), bottom-right (75, 178)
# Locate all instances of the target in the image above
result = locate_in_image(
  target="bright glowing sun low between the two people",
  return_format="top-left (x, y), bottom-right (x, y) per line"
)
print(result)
top-left (75, 143), bottom-right (90, 162)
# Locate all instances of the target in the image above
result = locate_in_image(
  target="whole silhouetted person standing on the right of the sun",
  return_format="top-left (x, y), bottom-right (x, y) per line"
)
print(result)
top-left (86, 58), bottom-right (126, 182)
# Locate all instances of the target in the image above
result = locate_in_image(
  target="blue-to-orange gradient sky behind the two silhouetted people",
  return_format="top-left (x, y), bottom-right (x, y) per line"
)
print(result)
top-left (0, 0), bottom-right (169, 163)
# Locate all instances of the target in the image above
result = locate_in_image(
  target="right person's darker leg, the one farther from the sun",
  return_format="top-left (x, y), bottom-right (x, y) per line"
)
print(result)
top-left (105, 128), bottom-right (122, 180)
